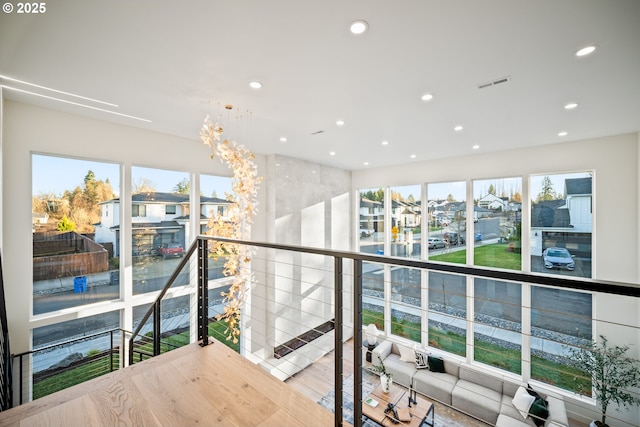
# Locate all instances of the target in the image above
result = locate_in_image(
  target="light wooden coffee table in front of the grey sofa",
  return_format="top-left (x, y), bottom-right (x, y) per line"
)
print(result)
top-left (362, 384), bottom-right (435, 427)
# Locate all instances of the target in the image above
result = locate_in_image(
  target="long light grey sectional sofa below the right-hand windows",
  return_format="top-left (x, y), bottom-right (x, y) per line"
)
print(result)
top-left (372, 340), bottom-right (569, 427)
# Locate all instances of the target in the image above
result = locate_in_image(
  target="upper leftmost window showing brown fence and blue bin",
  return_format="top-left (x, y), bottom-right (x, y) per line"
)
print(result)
top-left (31, 154), bottom-right (120, 314)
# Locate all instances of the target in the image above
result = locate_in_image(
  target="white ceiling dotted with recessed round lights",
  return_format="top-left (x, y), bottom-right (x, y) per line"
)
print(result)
top-left (0, 0), bottom-right (640, 170)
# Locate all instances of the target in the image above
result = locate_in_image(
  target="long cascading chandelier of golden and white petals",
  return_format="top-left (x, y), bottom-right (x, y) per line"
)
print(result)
top-left (200, 114), bottom-right (262, 344)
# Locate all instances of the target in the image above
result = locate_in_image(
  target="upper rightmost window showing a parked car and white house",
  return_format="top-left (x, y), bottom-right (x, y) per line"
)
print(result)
top-left (530, 173), bottom-right (593, 277)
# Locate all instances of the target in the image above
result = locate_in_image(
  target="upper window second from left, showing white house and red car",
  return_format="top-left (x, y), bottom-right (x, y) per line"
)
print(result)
top-left (131, 167), bottom-right (191, 295)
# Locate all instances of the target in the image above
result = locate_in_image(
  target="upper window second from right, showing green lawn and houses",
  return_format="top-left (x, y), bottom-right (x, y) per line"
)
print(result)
top-left (473, 178), bottom-right (522, 270)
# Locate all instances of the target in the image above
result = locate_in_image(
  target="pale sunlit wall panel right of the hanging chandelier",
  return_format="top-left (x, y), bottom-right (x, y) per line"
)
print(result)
top-left (266, 155), bottom-right (351, 345)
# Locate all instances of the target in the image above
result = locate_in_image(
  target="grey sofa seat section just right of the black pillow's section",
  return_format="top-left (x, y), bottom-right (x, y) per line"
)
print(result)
top-left (451, 380), bottom-right (502, 424)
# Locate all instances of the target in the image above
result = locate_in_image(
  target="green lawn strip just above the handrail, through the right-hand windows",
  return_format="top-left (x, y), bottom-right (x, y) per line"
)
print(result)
top-left (429, 243), bottom-right (522, 270)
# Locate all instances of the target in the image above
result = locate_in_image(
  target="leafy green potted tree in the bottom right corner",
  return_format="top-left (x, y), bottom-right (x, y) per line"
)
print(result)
top-left (569, 335), bottom-right (640, 427)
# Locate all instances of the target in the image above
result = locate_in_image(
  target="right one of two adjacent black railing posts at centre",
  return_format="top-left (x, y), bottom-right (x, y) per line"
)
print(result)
top-left (353, 259), bottom-right (362, 427)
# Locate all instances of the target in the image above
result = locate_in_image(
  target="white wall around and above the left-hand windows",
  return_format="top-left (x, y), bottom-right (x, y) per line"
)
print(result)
top-left (1, 100), bottom-right (265, 353)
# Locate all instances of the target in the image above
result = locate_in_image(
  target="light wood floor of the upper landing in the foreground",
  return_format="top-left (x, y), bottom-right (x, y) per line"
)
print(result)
top-left (0, 342), bottom-right (334, 427)
